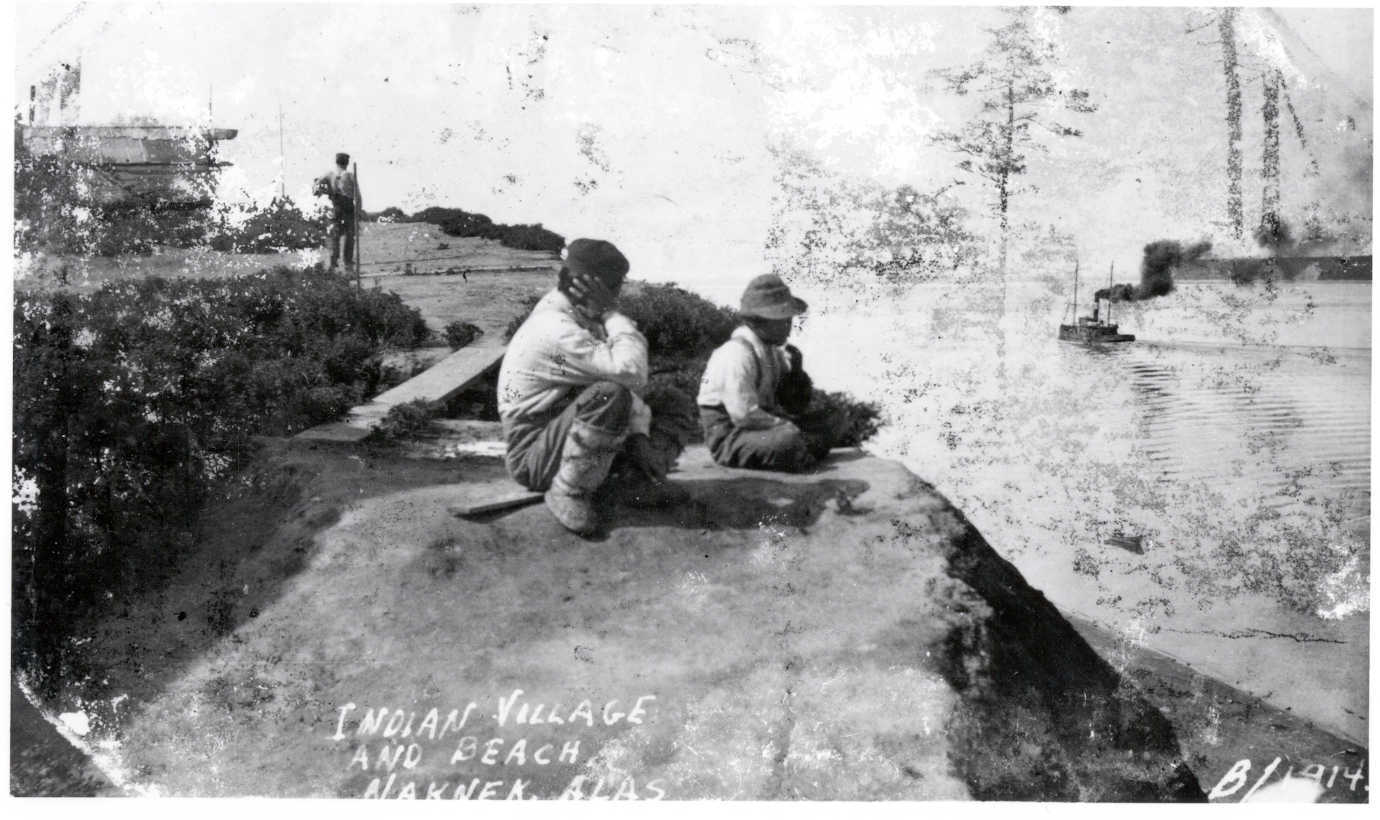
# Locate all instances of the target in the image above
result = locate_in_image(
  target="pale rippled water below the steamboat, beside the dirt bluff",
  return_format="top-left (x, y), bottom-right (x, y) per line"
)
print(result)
top-left (800, 282), bottom-right (1370, 739)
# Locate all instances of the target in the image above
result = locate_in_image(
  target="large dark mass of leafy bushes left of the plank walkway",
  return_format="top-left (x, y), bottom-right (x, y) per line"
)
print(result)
top-left (12, 268), bottom-right (428, 683)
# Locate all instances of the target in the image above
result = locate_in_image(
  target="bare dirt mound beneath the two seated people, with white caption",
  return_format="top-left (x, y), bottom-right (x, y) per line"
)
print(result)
top-left (21, 442), bottom-right (1203, 799)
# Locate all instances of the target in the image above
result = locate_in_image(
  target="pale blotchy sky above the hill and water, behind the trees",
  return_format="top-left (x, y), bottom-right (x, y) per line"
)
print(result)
top-left (14, 3), bottom-right (1373, 294)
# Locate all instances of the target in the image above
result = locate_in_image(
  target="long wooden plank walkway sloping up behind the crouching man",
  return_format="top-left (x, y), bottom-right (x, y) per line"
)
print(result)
top-left (297, 344), bottom-right (508, 443)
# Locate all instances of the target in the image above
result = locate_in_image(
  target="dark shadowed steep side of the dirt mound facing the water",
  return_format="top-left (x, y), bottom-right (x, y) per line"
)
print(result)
top-left (927, 511), bottom-right (1206, 802)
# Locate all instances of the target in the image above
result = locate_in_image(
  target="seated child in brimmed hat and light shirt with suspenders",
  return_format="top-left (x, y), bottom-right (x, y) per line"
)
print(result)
top-left (696, 273), bottom-right (847, 472)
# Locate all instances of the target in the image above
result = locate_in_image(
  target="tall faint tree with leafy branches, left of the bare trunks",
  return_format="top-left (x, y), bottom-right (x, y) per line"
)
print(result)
top-left (933, 7), bottom-right (1097, 289)
